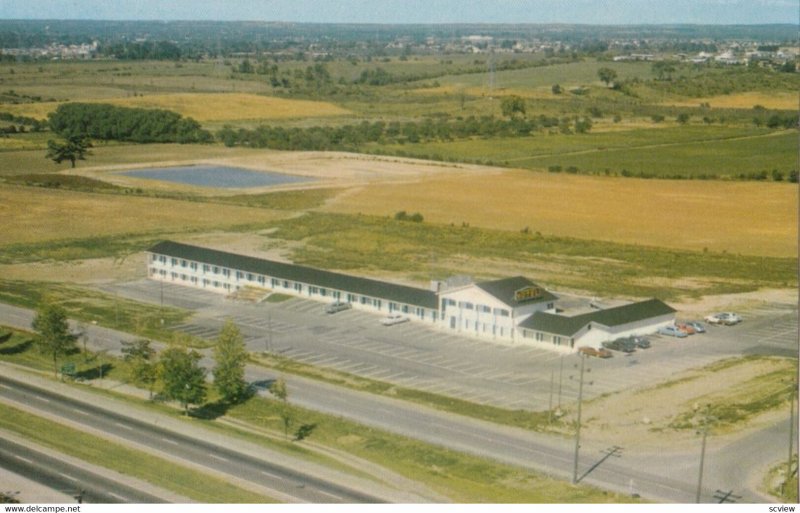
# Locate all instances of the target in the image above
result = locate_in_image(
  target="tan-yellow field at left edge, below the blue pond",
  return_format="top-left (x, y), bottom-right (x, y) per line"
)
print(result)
top-left (0, 186), bottom-right (280, 245)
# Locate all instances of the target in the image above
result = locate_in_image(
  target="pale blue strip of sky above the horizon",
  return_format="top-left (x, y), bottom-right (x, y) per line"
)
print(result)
top-left (0, 0), bottom-right (800, 25)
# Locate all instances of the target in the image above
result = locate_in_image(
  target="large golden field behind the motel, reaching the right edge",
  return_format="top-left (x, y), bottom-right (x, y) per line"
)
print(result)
top-left (325, 171), bottom-right (798, 257)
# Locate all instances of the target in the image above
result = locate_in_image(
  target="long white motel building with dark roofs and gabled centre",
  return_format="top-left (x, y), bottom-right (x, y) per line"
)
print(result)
top-left (147, 241), bottom-right (675, 352)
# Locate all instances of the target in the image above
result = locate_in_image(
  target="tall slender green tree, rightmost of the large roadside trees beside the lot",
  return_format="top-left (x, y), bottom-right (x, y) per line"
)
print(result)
top-left (214, 320), bottom-right (247, 404)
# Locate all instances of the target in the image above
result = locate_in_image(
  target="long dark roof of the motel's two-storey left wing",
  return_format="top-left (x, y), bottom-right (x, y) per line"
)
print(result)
top-left (148, 241), bottom-right (439, 310)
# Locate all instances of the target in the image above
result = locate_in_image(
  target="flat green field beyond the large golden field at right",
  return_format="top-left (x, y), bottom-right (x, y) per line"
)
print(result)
top-left (375, 126), bottom-right (797, 178)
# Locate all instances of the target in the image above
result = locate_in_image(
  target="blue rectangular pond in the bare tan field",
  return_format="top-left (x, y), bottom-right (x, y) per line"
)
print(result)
top-left (121, 166), bottom-right (311, 189)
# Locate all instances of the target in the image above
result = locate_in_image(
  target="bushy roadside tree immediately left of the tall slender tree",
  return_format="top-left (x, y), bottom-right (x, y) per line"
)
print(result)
top-left (159, 346), bottom-right (206, 415)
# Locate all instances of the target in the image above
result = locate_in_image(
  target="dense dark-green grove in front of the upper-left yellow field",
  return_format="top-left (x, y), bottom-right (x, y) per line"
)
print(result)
top-left (49, 103), bottom-right (213, 143)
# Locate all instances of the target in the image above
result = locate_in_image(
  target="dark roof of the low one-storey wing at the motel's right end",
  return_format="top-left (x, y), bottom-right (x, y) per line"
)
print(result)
top-left (520, 299), bottom-right (675, 336)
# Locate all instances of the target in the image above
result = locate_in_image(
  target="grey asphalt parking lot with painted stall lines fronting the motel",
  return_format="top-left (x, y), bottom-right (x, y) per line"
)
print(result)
top-left (107, 280), bottom-right (797, 410)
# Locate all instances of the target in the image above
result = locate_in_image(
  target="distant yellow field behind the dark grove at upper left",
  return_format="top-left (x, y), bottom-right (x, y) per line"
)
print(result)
top-left (2, 93), bottom-right (350, 122)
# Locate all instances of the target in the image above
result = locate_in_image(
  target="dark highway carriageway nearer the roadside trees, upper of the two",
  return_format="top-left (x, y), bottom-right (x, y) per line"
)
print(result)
top-left (0, 376), bottom-right (381, 503)
